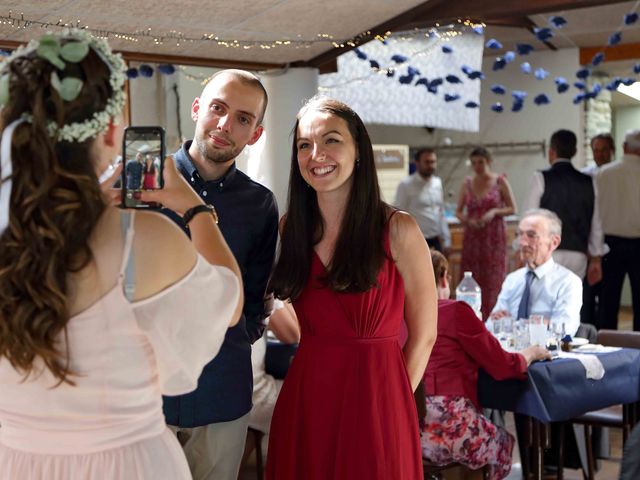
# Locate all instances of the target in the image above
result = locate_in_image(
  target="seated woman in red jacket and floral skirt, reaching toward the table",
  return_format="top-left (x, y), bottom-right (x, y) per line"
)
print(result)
top-left (421, 251), bottom-right (549, 480)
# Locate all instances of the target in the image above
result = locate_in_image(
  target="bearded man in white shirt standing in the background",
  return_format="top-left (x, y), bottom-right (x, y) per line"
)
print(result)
top-left (395, 148), bottom-right (451, 252)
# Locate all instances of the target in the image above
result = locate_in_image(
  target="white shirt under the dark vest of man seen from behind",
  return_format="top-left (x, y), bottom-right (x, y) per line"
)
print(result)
top-left (523, 159), bottom-right (609, 278)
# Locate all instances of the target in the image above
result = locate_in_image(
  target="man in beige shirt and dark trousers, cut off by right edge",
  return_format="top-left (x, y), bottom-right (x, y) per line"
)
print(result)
top-left (596, 130), bottom-right (640, 330)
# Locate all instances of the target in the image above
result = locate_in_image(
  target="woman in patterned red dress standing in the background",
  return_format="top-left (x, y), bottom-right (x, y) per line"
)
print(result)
top-left (456, 147), bottom-right (516, 320)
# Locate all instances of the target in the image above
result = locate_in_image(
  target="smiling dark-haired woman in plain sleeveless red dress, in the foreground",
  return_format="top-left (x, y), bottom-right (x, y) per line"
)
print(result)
top-left (266, 98), bottom-right (436, 480)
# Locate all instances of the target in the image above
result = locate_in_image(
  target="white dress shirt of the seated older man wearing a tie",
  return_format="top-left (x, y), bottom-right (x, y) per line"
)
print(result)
top-left (493, 258), bottom-right (582, 336)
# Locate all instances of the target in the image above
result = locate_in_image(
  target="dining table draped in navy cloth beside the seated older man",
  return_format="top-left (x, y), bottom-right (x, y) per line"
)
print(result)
top-left (478, 348), bottom-right (640, 479)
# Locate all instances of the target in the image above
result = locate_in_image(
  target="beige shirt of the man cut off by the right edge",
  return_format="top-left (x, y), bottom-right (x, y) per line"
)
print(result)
top-left (596, 154), bottom-right (640, 238)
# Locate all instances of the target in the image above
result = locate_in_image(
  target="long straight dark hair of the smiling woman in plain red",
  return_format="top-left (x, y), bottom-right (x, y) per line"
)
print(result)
top-left (270, 97), bottom-right (390, 299)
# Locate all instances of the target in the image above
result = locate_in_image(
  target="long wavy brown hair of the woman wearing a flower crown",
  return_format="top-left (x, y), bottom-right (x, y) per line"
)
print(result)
top-left (0, 39), bottom-right (113, 384)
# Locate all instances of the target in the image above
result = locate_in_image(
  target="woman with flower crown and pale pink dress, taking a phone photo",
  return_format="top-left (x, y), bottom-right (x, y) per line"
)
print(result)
top-left (0, 31), bottom-right (242, 480)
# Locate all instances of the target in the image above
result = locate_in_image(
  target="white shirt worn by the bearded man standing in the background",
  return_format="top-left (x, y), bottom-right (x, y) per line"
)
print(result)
top-left (395, 172), bottom-right (451, 247)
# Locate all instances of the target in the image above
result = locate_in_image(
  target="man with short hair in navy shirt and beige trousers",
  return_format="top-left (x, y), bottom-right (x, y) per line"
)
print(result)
top-left (164, 70), bottom-right (278, 480)
